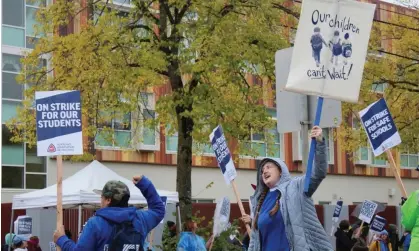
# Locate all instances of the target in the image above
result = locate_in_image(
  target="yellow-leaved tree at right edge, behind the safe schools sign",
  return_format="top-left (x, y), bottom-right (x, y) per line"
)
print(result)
top-left (340, 2), bottom-right (419, 157)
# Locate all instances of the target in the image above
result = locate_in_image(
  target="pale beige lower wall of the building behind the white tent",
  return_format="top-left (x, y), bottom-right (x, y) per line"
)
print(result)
top-left (1, 160), bottom-right (419, 205)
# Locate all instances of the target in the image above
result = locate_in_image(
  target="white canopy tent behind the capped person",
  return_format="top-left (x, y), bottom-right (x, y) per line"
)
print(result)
top-left (10, 160), bottom-right (179, 235)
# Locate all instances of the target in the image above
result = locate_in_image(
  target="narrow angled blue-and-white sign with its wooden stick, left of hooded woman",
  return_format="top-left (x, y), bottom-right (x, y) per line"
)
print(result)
top-left (210, 125), bottom-right (251, 235)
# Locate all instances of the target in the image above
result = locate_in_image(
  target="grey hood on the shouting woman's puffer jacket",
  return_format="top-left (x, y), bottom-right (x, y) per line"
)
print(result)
top-left (253, 158), bottom-right (291, 200)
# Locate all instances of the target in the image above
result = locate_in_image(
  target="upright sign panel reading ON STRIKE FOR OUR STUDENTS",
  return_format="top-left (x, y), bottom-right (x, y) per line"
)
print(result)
top-left (35, 91), bottom-right (83, 156)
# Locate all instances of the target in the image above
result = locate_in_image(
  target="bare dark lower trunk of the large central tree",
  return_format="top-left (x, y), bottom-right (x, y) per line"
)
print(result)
top-left (176, 105), bottom-right (194, 225)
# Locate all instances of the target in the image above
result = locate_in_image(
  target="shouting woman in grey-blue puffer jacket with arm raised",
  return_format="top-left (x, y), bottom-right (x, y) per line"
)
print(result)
top-left (248, 126), bottom-right (333, 251)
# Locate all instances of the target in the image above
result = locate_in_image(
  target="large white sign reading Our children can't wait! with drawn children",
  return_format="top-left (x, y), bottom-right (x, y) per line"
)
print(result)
top-left (285, 0), bottom-right (375, 103)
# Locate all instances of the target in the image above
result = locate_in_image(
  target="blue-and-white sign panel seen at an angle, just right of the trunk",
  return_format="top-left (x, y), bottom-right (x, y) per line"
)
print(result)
top-left (210, 126), bottom-right (237, 185)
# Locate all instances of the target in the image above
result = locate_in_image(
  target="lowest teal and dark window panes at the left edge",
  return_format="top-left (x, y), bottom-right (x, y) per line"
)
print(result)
top-left (1, 124), bottom-right (47, 189)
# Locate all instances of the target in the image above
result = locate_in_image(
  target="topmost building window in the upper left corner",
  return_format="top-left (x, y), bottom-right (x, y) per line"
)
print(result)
top-left (2, 0), bottom-right (46, 48)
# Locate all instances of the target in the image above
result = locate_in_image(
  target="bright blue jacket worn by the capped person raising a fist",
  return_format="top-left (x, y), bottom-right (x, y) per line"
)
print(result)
top-left (57, 176), bottom-right (165, 251)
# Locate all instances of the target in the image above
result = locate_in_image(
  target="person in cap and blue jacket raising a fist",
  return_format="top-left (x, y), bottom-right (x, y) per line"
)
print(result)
top-left (54, 176), bottom-right (165, 251)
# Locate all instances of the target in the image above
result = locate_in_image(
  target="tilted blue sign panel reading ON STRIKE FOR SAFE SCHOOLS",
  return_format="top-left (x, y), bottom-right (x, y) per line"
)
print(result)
top-left (359, 99), bottom-right (402, 156)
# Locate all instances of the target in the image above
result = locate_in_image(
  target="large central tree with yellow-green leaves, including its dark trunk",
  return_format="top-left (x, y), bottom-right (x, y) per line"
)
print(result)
top-left (9, 0), bottom-right (289, 220)
